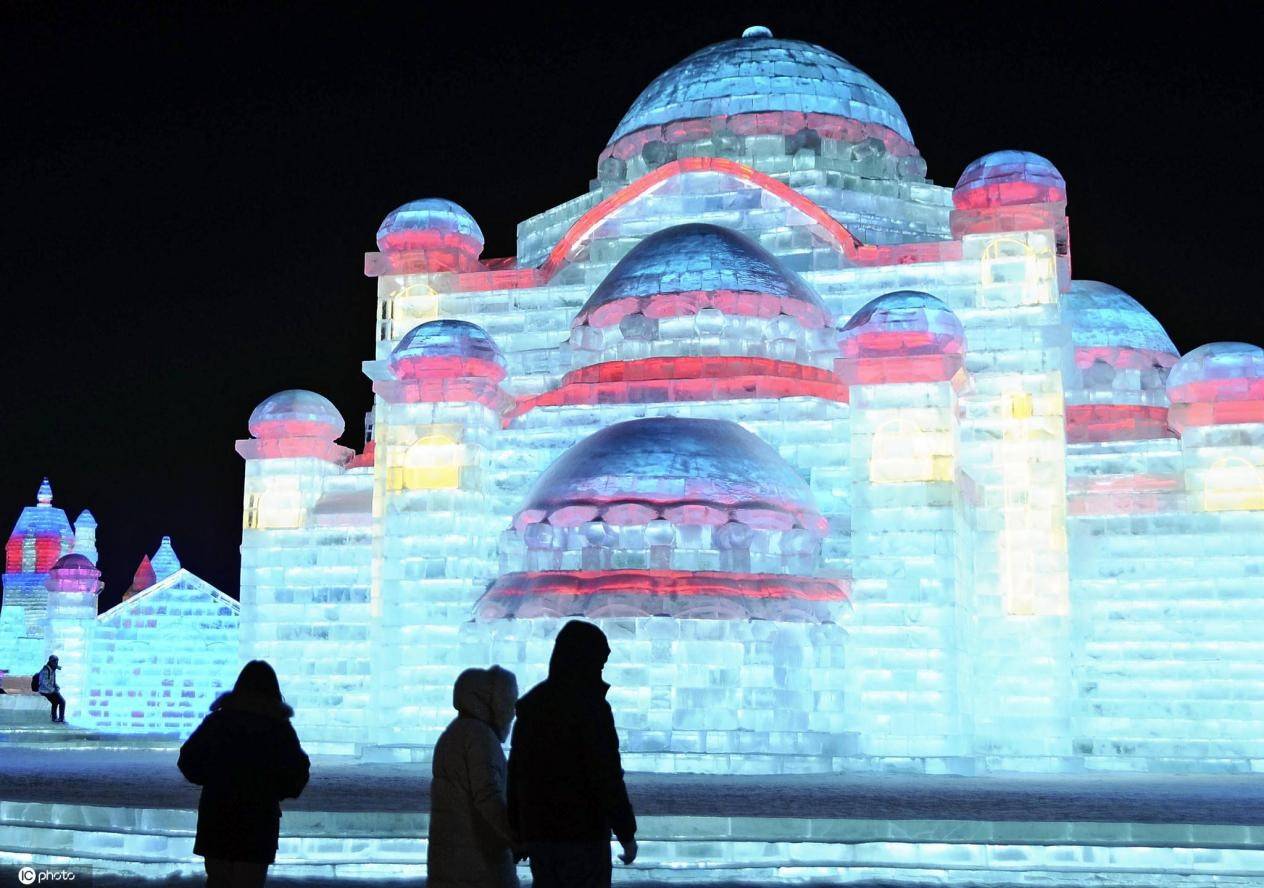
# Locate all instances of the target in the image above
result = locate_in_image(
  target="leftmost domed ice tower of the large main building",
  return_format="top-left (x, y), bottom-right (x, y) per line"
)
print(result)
top-left (238, 390), bottom-right (373, 753)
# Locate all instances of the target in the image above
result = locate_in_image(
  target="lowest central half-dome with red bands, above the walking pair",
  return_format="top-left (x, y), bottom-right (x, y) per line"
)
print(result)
top-left (479, 417), bottom-right (847, 621)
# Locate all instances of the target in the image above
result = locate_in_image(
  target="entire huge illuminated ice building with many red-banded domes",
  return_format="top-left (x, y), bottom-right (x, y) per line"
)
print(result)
top-left (238, 28), bottom-right (1264, 773)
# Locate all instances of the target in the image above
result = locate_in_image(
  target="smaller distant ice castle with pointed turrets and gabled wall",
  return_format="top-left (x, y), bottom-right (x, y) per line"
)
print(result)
top-left (0, 485), bottom-right (238, 736)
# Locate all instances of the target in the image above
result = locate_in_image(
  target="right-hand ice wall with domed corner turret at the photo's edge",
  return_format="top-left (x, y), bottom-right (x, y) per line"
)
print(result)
top-left (1072, 342), bottom-right (1264, 769)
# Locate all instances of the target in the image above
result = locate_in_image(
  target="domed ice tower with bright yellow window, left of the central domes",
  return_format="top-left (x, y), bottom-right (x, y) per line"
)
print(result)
top-left (372, 321), bottom-right (509, 744)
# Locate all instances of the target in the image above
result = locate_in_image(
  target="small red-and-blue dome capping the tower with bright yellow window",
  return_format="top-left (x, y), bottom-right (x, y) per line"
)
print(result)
top-left (389, 318), bottom-right (506, 381)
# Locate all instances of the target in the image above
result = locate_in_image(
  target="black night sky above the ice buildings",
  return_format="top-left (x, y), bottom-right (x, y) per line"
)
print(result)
top-left (0, 3), bottom-right (1264, 603)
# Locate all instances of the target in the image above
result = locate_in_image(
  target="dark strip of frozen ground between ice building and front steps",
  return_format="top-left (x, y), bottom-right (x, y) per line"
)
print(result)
top-left (0, 749), bottom-right (1264, 825)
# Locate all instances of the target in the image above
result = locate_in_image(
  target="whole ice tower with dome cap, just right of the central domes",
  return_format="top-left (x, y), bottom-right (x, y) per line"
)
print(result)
top-left (838, 292), bottom-right (968, 758)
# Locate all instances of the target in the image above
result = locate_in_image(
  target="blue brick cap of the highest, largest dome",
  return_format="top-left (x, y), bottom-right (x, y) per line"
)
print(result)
top-left (611, 27), bottom-right (913, 144)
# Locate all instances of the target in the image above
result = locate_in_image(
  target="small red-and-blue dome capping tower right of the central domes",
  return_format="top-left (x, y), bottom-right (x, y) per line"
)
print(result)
top-left (838, 289), bottom-right (966, 357)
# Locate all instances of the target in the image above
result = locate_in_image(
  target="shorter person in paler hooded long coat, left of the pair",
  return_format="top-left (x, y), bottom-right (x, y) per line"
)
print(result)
top-left (426, 666), bottom-right (518, 888)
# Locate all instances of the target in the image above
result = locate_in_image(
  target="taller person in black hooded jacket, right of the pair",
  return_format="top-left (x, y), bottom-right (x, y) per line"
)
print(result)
top-left (509, 620), bottom-right (637, 888)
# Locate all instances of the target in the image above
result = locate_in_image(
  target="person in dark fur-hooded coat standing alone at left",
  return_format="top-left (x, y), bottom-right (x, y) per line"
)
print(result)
top-left (178, 659), bottom-right (310, 888)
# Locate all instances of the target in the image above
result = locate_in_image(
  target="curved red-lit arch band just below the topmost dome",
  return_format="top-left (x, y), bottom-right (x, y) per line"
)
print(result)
top-left (541, 157), bottom-right (861, 278)
